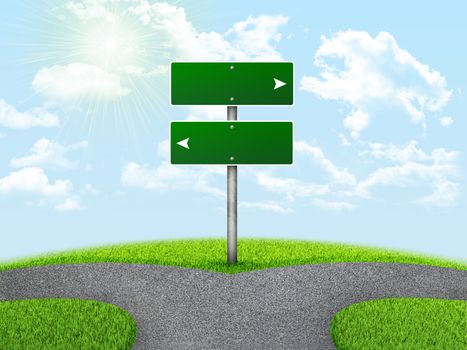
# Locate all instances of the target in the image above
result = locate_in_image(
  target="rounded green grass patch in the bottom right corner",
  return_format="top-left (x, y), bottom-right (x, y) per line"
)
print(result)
top-left (331, 298), bottom-right (467, 350)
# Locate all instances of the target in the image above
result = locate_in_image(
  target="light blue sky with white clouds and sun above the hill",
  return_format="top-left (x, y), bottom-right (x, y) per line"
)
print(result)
top-left (0, 0), bottom-right (467, 261)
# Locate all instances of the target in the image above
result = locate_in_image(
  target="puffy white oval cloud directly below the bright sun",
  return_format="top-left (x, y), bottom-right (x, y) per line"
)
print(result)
top-left (32, 63), bottom-right (130, 102)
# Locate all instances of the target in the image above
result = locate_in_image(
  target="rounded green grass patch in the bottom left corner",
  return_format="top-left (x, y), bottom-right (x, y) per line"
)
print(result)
top-left (0, 299), bottom-right (136, 350)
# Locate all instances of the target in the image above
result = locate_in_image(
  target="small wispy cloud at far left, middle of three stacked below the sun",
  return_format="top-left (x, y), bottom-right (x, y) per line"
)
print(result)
top-left (10, 138), bottom-right (88, 169)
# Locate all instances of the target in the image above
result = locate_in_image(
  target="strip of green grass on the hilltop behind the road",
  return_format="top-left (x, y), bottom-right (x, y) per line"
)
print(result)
top-left (0, 239), bottom-right (467, 273)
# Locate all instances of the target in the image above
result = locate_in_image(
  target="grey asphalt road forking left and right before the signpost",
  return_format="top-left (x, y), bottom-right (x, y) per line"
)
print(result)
top-left (0, 263), bottom-right (467, 350)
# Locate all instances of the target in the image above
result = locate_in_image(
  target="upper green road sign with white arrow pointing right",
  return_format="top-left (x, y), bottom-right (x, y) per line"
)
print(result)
top-left (171, 62), bottom-right (294, 106)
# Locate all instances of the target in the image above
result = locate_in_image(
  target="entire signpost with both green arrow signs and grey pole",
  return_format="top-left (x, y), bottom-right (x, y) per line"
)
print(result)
top-left (170, 62), bottom-right (293, 264)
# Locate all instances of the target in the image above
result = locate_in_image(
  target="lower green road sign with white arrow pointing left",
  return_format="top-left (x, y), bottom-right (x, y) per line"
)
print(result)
top-left (170, 121), bottom-right (293, 165)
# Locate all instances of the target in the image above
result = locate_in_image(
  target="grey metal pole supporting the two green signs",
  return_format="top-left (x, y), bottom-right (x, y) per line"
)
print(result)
top-left (227, 106), bottom-right (237, 264)
